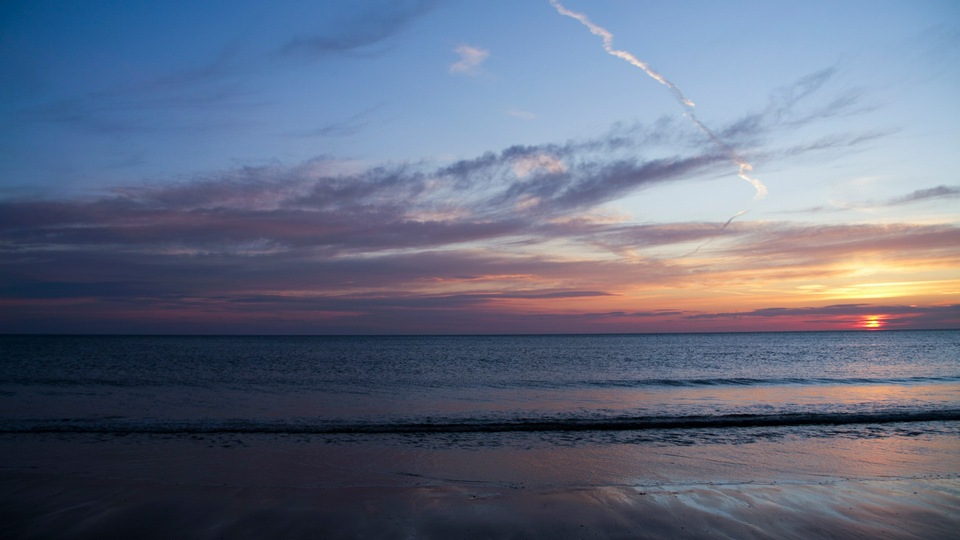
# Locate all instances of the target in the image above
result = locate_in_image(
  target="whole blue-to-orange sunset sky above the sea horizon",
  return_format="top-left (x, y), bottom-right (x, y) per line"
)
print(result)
top-left (0, 0), bottom-right (960, 334)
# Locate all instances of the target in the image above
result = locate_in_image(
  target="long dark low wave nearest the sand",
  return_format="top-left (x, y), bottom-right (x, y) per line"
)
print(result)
top-left (0, 409), bottom-right (960, 435)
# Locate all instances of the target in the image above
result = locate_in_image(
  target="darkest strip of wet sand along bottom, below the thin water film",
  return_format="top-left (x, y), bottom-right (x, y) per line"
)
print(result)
top-left (0, 469), bottom-right (960, 539)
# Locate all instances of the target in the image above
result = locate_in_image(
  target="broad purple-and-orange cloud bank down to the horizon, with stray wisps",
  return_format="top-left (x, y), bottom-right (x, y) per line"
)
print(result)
top-left (0, 61), bottom-right (960, 332)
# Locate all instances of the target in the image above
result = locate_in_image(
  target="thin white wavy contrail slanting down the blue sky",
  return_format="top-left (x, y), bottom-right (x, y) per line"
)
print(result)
top-left (550, 0), bottom-right (767, 200)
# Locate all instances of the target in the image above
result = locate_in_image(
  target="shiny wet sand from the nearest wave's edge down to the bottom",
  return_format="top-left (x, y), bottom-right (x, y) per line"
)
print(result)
top-left (0, 426), bottom-right (960, 539)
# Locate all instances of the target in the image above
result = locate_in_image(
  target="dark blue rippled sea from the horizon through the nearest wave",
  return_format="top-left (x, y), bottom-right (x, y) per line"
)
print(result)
top-left (0, 331), bottom-right (960, 444)
